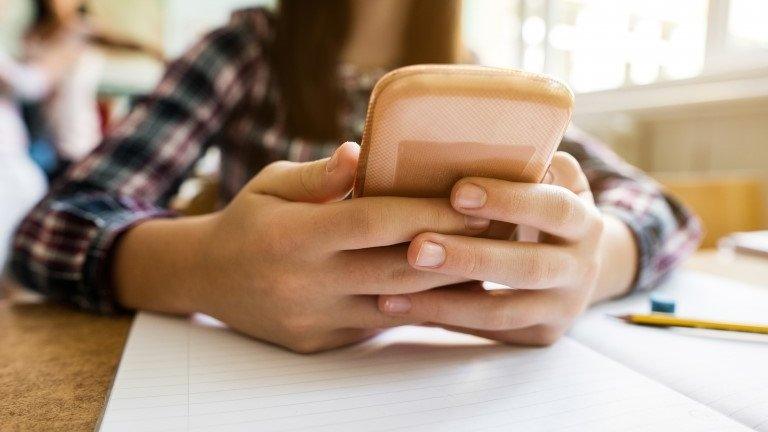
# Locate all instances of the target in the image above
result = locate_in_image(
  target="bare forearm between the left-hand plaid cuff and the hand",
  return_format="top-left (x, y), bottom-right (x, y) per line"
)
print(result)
top-left (111, 215), bottom-right (212, 314)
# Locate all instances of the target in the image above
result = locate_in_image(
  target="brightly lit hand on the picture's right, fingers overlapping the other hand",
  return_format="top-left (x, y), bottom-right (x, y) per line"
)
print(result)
top-left (379, 152), bottom-right (603, 345)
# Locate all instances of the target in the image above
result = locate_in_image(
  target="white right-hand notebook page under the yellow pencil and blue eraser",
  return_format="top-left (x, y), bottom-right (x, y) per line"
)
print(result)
top-left (570, 271), bottom-right (768, 432)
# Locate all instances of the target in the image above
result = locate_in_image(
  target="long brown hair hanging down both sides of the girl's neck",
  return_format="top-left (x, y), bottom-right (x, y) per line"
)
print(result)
top-left (273, 0), bottom-right (460, 141)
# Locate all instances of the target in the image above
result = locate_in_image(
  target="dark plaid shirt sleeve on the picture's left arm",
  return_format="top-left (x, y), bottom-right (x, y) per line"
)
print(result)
top-left (11, 25), bottom-right (262, 313)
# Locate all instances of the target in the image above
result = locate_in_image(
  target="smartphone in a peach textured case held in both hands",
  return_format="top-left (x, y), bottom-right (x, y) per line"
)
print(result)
top-left (353, 65), bottom-right (573, 197)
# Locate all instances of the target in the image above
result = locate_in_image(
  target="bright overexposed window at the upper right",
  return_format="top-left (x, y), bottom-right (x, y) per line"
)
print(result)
top-left (463, 0), bottom-right (768, 92)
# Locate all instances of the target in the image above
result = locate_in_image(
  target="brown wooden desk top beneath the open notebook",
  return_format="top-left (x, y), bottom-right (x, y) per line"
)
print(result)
top-left (0, 251), bottom-right (768, 431)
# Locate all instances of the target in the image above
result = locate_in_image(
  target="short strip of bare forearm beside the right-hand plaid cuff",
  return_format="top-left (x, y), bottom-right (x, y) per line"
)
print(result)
top-left (591, 215), bottom-right (638, 303)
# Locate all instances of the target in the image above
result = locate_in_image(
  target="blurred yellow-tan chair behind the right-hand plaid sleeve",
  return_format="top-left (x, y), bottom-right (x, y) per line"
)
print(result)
top-left (654, 172), bottom-right (766, 248)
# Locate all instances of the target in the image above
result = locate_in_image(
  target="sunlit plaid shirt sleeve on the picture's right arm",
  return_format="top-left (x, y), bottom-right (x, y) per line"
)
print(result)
top-left (560, 129), bottom-right (702, 290)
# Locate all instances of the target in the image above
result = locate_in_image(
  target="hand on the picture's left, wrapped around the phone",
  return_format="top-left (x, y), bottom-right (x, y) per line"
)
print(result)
top-left (194, 143), bottom-right (488, 352)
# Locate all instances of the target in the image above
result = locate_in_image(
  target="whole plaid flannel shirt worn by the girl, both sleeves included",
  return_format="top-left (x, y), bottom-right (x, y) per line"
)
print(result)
top-left (11, 9), bottom-right (701, 313)
